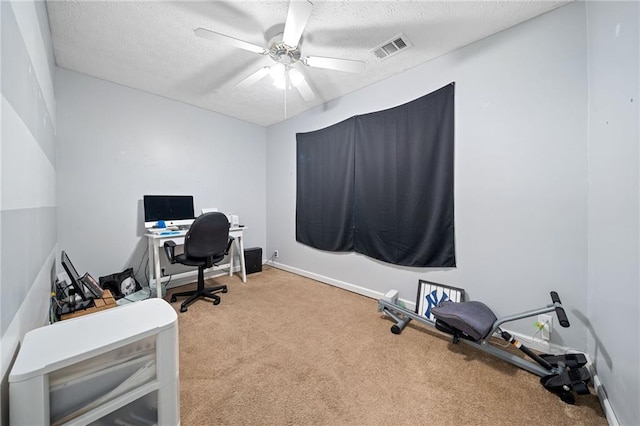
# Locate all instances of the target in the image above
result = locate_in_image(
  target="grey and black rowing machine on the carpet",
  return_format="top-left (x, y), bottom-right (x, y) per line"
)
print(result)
top-left (378, 290), bottom-right (591, 404)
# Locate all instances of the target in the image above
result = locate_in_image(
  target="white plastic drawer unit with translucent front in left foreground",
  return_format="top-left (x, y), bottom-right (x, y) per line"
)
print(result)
top-left (9, 299), bottom-right (180, 426)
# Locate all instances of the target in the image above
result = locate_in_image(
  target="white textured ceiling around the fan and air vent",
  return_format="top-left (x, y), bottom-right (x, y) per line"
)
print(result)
top-left (47, 0), bottom-right (567, 126)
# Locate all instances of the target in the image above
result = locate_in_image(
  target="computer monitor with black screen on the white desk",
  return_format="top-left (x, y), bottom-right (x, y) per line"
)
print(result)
top-left (144, 195), bottom-right (195, 228)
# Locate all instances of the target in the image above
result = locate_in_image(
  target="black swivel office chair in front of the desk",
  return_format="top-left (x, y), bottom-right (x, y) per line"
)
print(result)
top-left (164, 212), bottom-right (233, 312)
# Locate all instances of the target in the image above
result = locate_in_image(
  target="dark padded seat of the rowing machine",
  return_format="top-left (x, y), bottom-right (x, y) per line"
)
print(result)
top-left (431, 300), bottom-right (497, 340)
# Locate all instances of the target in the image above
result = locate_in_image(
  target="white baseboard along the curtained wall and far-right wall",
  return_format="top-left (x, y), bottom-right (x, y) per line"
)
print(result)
top-left (263, 261), bottom-right (619, 426)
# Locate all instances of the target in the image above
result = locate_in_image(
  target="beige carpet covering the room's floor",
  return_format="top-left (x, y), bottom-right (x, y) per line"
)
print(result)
top-left (167, 267), bottom-right (607, 426)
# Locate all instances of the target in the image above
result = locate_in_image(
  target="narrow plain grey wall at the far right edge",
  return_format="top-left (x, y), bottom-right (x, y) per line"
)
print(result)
top-left (587, 2), bottom-right (640, 425)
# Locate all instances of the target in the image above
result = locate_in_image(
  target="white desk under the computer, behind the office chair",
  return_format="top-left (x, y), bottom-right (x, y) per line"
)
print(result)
top-left (144, 226), bottom-right (247, 297)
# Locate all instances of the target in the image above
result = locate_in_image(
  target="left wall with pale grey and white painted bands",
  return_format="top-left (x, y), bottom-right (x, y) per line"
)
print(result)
top-left (0, 1), bottom-right (57, 424)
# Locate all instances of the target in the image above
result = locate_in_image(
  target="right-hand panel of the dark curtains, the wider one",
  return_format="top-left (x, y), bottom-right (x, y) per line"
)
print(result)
top-left (354, 85), bottom-right (455, 266)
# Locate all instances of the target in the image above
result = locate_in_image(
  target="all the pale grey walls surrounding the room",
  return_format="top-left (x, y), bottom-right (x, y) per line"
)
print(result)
top-left (0, 2), bottom-right (640, 424)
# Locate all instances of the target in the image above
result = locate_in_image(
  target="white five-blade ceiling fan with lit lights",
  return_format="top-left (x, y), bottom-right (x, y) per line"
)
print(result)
top-left (194, 0), bottom-right (364, 102)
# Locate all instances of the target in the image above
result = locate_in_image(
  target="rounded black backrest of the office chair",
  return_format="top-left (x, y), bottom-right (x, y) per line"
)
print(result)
top-left (184, 212), bottom-right (229, 258)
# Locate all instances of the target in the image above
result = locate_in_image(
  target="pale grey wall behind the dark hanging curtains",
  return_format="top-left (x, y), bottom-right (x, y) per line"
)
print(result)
top-left (266, 3), bottom-right (587, 349)
